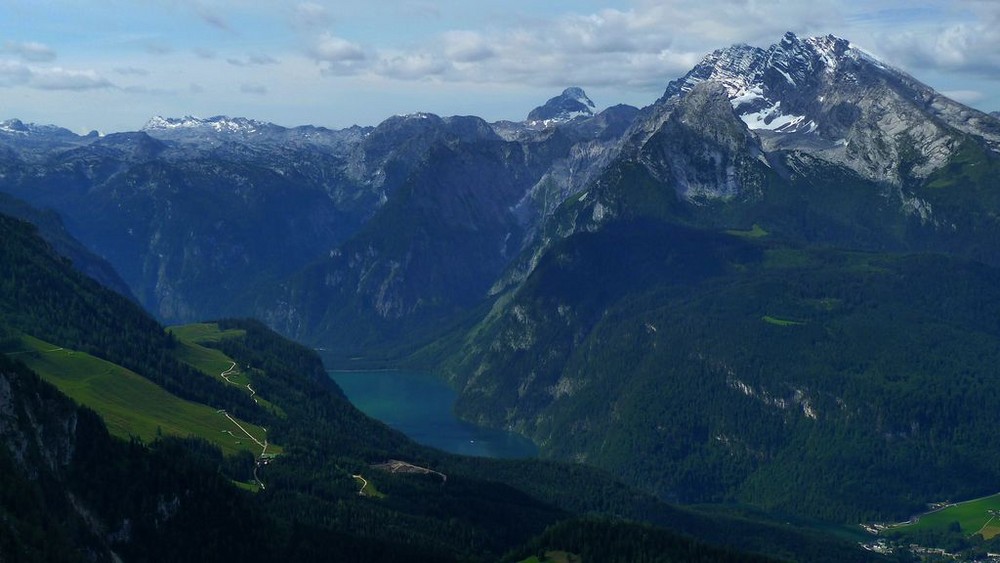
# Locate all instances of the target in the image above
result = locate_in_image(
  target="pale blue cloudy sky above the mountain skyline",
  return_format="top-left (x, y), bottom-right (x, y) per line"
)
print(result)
top-left (0, 0), bottom-right (1000, 132)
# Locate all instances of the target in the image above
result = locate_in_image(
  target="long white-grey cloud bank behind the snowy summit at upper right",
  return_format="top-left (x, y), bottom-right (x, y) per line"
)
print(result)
top-left (300, 0), bottom-right (1000, 103)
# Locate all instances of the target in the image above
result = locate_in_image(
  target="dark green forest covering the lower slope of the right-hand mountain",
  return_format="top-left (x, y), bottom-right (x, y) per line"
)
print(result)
top-left (448, 214), bottom-right (1000, 523)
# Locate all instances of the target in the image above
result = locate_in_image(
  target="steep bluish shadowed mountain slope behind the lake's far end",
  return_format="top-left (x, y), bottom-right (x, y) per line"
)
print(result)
top-left (256, 102), bottom-right (633, 357)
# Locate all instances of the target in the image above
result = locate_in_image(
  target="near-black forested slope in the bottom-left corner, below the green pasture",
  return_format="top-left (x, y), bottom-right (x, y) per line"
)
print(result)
top-left (0, 356), bottom-right (454, 562)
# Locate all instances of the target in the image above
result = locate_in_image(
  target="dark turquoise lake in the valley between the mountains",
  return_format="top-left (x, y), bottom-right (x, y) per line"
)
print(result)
top-left (328, 371), bottom-right (538, 458)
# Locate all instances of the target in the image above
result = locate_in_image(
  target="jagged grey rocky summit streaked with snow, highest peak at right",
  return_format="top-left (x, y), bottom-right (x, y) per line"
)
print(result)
top-left (660, 33), bottom-right (1000, 184)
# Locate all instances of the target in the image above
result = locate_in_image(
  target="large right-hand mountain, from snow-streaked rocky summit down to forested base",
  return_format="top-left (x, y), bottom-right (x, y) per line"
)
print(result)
top-left (444, 30), bottom-right (1000, 522)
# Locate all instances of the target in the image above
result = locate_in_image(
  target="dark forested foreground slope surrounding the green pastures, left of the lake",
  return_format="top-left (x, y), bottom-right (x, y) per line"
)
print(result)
top-left (0, 210), bottom-right (876, 561)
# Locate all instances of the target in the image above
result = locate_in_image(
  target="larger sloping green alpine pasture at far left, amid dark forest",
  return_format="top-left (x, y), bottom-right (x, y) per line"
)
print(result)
top-left (18, 336), bottom-right (273, 455)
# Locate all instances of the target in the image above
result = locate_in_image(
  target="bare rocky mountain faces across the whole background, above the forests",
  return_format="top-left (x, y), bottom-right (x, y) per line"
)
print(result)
top-left (0, 30), bottom-right (1000, 354)
